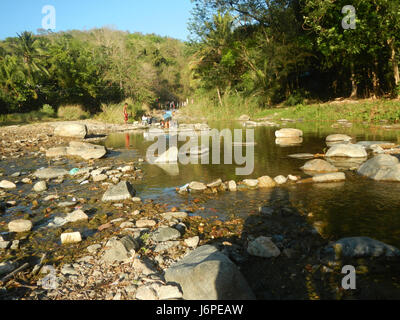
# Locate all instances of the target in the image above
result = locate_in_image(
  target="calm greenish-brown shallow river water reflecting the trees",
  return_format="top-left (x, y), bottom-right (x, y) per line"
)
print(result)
top-left (103, 122), bottom-right (400, 247)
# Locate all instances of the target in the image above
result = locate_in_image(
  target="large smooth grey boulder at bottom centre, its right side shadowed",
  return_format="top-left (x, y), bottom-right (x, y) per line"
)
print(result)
top-left (165, 245), bottom-right (255, 300)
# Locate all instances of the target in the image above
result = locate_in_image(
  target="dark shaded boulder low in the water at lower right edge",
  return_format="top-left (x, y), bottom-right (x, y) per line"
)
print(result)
top-left (323, 237), bottom-right (400, 260)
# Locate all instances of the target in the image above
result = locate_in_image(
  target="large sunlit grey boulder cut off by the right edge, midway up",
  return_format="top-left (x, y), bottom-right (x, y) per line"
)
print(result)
top-left (358, 154), bottom-right (400, 181)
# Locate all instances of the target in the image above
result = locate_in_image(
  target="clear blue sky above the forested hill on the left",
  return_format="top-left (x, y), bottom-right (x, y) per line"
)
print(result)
top-left (0, 0), bottom-right (192, 40)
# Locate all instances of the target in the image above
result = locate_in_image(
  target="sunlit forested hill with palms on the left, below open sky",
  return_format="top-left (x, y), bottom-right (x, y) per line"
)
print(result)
top-left (0, 28), bottom-right (189, 113)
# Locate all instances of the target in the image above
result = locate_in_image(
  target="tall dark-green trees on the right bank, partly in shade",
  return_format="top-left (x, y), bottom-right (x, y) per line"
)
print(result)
top-left (190, 0), bottom-right (400, 105)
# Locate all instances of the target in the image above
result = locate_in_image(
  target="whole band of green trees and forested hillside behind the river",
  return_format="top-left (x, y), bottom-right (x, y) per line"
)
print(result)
top-left (0, 0), bottom-right (400, 113)
